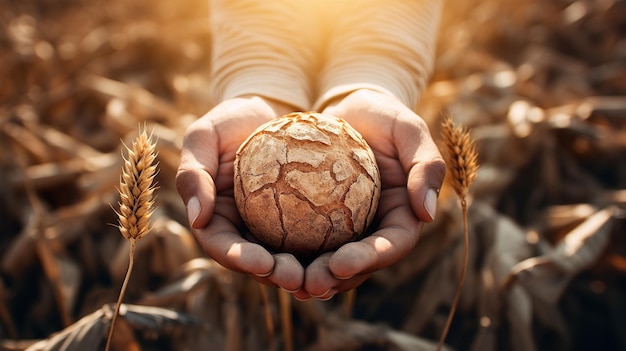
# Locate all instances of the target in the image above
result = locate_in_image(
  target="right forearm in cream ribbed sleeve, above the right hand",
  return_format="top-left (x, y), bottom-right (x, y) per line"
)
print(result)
top-left (314, 0), bottom-right (442, 110)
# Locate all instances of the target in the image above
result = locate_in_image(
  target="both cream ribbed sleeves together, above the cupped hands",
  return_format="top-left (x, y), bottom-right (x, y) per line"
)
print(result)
top-left (210, 0), bottom-right (442, 110)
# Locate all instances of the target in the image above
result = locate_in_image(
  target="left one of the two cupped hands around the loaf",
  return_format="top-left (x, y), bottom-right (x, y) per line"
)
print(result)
top-left (176, 97), bottom-right (304, 292)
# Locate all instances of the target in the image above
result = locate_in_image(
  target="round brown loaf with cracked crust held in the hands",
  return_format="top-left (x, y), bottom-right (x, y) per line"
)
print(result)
top-left (234, 112), bottom-right (380, 259)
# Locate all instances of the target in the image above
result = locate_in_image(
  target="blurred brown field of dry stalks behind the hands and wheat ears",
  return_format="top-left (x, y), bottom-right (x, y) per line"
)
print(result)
top-left (0, 0), bottom-right (626, 351)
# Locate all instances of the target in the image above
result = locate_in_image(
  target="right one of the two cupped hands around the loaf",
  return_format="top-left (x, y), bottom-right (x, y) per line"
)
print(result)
top-left (294, 90), bottom-right (446, 299)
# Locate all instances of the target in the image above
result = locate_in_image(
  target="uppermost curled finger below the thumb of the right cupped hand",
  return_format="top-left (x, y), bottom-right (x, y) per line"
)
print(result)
top-left (328, 192), bottom-right (423, 279)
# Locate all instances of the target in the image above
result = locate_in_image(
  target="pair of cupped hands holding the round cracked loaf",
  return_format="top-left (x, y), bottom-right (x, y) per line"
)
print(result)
top-left (176, 90), bottom-right (446, 300)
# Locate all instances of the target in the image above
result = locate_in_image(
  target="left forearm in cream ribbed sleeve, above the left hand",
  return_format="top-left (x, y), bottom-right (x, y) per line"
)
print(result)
top-left (210, 0), bottom-right (315, 110)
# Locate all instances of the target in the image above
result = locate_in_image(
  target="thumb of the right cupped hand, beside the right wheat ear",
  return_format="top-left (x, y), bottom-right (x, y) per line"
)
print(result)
top-left (393, 111), bottom-right (446, 222)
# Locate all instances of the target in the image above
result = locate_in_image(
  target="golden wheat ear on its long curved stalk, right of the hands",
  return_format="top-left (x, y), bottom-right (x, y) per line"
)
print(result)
top-left (437, 116), bottom-right (478, 350)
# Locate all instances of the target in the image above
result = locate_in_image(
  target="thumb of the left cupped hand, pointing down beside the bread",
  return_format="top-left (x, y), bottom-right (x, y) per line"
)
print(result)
top-left (176, 120), bottom-right (219, 228)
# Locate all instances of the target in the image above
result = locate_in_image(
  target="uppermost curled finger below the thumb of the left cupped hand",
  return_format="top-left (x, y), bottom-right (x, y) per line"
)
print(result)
top-left (193, 215), bottom-right (275, 277)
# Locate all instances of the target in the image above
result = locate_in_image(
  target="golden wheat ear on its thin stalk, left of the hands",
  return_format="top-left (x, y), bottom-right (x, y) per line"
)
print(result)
top-left (105, 127), bottom-right (158, 351)
